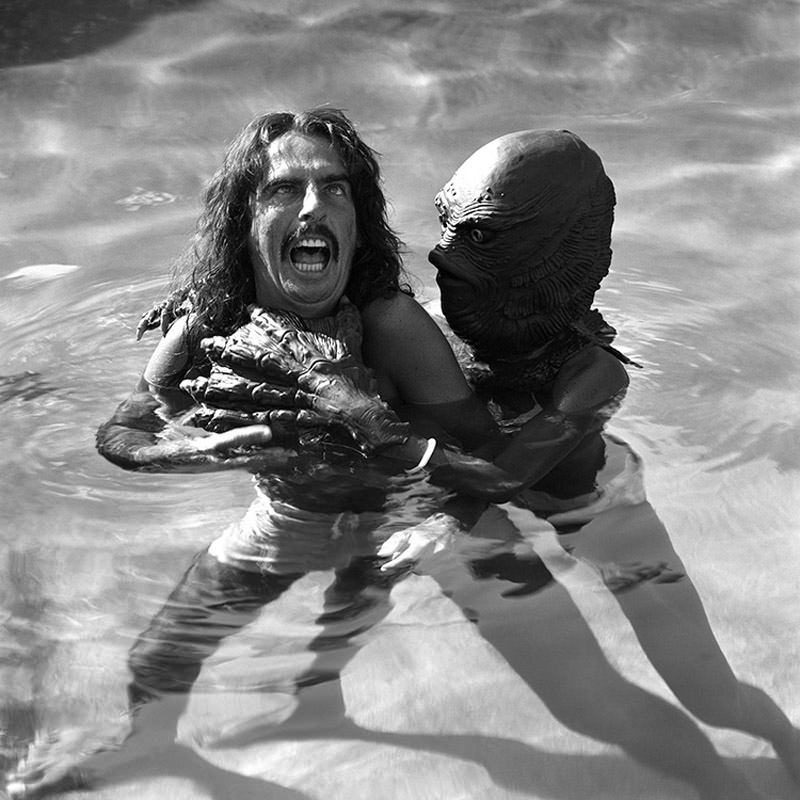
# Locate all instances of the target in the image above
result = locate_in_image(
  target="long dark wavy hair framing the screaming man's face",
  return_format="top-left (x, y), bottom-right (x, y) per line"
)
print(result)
top-left (172, 107), bottom-right (410, 335)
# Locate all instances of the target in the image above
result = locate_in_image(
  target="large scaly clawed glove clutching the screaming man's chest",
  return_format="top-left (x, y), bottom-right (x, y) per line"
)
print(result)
top-left (181, 303), bottom-right (408, 453)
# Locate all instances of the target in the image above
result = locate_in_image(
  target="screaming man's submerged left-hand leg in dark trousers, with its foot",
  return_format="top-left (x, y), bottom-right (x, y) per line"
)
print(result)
top-left (6, 552), bottom-right (299, 800)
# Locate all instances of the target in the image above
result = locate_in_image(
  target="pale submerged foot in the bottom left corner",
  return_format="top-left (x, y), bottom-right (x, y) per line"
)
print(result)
top-left (5, 726), bottom-right (129, 800)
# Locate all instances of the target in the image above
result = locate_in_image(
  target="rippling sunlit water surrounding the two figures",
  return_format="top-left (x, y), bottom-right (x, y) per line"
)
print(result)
top-left (0, 0), bottom-right (800, 800)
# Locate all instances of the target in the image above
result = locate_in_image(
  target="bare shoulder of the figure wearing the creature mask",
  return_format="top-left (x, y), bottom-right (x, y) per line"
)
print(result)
top-left (553, 347), bottom-right (630, 414)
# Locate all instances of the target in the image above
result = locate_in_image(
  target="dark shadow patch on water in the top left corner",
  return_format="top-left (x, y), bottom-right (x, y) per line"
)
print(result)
top-left (0, 0), bottom-right (209, 67)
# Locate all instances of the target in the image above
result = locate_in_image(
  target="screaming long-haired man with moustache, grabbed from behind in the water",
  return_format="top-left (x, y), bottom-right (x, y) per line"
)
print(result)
top-left (8, 108), bottom-right (521, 798)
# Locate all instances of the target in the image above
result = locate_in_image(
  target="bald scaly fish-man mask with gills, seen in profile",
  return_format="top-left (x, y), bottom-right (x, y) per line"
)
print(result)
top-left (429, 130), bottom-right (615, 362)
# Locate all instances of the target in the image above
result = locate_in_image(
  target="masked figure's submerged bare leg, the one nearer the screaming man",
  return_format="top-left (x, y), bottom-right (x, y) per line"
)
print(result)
top-left (434, 544), bottom-right (759, 800)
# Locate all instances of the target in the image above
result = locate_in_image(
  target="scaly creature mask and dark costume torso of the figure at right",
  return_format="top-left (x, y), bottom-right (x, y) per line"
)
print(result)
top-left (430, 125), bottom-right (639, 510)
